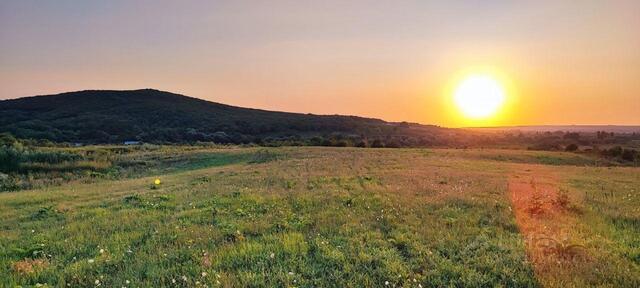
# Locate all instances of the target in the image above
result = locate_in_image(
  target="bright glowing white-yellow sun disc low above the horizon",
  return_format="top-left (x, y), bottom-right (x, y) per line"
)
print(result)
top-left (453, 74), bottom-right (505, 119)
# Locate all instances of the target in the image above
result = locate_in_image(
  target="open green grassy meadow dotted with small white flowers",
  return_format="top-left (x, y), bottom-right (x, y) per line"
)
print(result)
top-left (0, 147), bottom-right (640, 287)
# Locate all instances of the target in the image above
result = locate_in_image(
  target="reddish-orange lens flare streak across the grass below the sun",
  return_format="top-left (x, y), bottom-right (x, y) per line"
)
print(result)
top-left (509, 165), bottom-right (587, 286)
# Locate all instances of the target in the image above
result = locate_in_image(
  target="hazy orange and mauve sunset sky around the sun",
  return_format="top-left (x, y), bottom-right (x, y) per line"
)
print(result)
top-left (0, 0), bottom-right (640, 126)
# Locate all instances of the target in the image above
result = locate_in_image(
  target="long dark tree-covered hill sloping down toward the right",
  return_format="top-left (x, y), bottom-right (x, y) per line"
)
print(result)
top-left (0, 89), bottom-right (458, 146)
